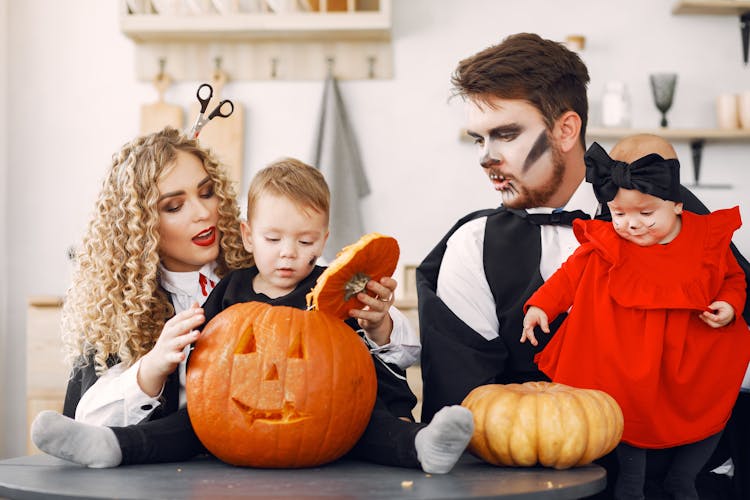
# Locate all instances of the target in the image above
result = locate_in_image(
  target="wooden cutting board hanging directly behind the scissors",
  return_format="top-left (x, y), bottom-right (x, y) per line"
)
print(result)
top-left (189, 70), bottom-right (245, 188)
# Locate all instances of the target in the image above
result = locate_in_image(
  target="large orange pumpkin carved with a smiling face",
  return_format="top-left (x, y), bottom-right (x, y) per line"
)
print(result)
top-left (187, 302), bottom-right (377, 467)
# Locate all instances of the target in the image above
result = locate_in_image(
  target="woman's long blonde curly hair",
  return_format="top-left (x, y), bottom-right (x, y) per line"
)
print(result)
top-left (62, 127), bottom-right (253, 373)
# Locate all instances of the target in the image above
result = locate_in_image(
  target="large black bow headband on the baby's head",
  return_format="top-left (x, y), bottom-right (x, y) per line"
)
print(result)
top-left (583, 142), bottom-right (682, 203)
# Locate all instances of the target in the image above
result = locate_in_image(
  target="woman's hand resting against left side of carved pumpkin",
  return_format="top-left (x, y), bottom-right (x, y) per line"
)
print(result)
top-left (137, 302), bottom-right (206, 397)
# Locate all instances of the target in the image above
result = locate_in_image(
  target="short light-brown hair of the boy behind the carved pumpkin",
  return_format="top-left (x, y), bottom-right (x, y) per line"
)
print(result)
top-left (247, 158), bottom-right (331, 224)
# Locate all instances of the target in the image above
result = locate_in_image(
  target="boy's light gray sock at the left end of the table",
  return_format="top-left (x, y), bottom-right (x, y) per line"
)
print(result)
top-left (31, 410), bottom-right (122, 469)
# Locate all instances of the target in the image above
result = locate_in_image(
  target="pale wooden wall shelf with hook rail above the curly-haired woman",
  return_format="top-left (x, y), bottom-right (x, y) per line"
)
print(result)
top-left (119, 0), bottom-right (393, 82)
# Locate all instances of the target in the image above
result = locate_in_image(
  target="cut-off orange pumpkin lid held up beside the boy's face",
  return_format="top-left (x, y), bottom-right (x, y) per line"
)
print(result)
top-left (307, 233), bottom-right (399, 319)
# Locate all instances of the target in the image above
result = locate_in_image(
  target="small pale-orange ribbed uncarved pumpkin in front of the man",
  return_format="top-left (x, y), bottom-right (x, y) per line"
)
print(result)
top-left (461, 382), bottom-right (623, 469)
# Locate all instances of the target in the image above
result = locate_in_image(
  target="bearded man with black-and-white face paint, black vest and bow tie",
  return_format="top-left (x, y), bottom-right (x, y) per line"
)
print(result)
top-left (417, 33), bottom-right (750, 498)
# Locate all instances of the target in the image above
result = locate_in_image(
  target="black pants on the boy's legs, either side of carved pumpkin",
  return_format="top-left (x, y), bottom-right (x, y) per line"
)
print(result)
top-left (112, 359), bottom-right (424, 468)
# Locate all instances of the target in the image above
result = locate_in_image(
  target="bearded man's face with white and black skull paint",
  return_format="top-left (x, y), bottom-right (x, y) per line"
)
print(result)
top-left (467, 98), bottom-right (565, 208)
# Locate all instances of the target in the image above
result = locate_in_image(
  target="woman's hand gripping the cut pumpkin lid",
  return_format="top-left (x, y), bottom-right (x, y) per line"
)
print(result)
top-left (349, 277), bottom-right (398, 345)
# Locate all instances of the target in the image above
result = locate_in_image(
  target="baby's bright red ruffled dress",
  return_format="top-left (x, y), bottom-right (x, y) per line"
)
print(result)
top-left (526, 207), bottom-right (750, 448)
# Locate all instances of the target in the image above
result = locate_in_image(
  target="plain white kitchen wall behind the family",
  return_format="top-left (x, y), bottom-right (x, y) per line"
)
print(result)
top-left (0, 0), bottom-right (750, 457)
